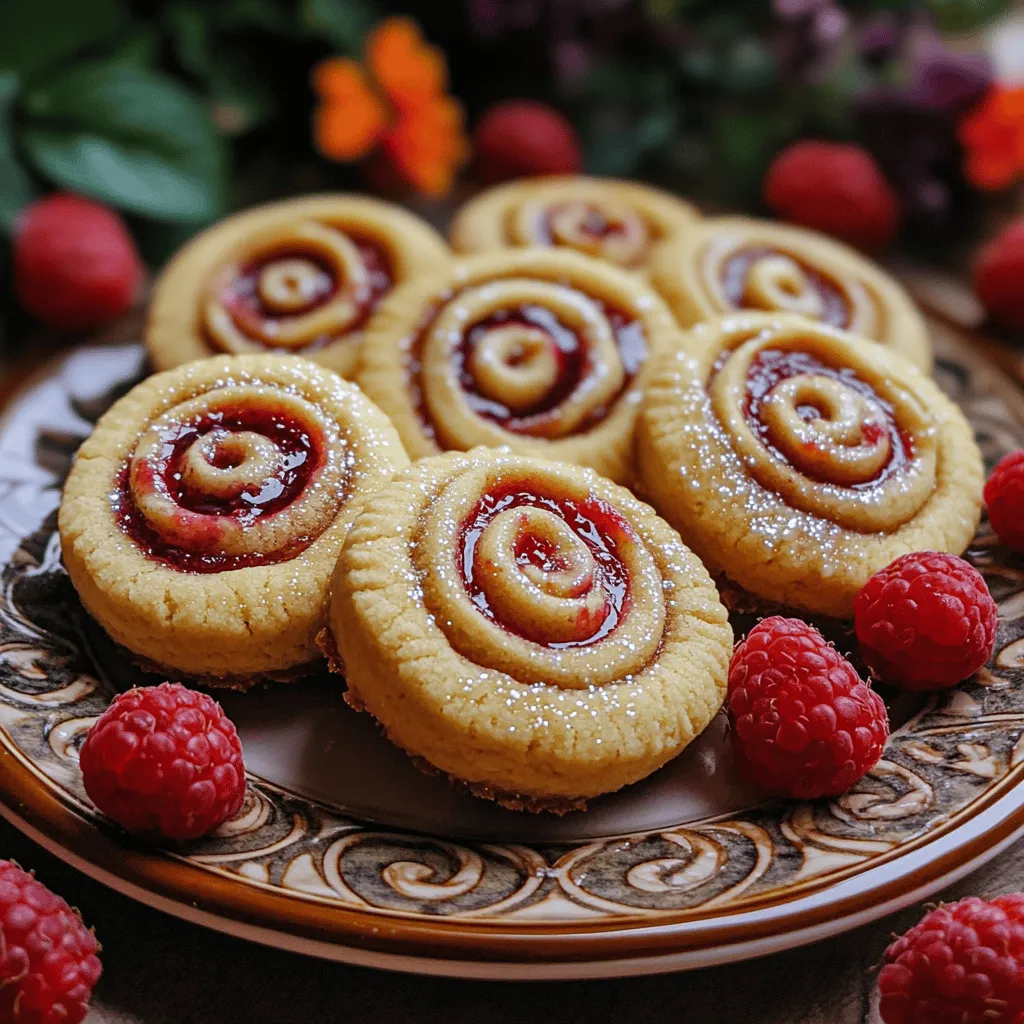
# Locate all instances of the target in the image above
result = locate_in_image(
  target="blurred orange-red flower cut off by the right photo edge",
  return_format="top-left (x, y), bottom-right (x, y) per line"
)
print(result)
top-left (959, 85), bottom-right (1024, 189)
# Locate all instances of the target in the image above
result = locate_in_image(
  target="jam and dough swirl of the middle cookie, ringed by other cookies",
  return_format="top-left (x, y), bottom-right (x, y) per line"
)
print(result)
top-left (413, 278), bottom-right (647, 447)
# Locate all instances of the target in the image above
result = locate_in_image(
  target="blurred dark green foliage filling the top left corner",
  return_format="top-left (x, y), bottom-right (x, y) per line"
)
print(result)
top-left (0, 0), bottom-right (377, 241)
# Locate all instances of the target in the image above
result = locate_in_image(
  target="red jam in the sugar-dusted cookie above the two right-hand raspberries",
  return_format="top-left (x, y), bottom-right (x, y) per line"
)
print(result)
top-left (726, 349), bottom-right (913, 489)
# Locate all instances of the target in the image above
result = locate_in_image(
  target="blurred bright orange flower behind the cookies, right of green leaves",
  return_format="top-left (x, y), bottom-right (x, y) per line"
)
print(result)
top-left (312, 17), bottom-right (469, 196)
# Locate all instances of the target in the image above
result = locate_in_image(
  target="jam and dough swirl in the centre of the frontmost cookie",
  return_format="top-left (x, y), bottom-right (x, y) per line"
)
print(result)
top-left (415, 464), bottom-right (665, 687)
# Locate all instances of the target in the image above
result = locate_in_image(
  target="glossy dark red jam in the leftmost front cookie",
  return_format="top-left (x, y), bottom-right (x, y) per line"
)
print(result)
top-left (112, 409), bottom-right (326, 572)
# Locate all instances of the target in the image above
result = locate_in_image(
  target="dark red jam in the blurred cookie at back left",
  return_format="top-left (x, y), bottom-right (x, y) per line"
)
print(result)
top-left (220, 236), bottom-right (394, 348)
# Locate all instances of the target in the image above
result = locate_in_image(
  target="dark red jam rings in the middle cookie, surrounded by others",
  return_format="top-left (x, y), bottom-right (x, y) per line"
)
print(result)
top-left (407, 300), bottom-right (647, 436)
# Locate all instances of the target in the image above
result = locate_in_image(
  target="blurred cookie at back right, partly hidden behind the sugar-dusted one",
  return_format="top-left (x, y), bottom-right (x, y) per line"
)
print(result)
top-left (650, 217), bottom-right (932, 371)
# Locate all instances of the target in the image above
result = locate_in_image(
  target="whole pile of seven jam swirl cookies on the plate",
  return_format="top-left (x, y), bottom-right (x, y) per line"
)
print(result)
top-left (59, 177), bottom-right (983, 812)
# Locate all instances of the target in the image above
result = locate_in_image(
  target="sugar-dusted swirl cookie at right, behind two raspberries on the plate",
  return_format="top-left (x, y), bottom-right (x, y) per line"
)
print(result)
top-left (637, 313), bottom-right (983, 617)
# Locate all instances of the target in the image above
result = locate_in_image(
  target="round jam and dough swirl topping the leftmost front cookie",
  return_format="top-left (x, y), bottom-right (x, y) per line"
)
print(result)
top-left (119, 385), bottom-right (346, 572)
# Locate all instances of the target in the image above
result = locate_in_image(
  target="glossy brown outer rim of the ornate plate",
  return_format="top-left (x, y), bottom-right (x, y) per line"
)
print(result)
top-left (0, 321), bottom-right (1024, 979)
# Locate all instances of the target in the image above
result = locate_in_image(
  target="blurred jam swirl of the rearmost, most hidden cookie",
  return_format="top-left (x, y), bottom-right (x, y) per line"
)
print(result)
top-left (512, 199), bottom-right (652, 267)
